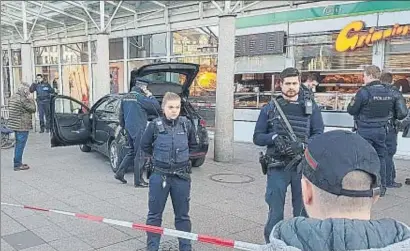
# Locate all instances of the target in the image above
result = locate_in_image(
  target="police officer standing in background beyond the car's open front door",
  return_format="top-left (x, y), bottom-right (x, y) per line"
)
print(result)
top-left (30, 74), bottom-right (55, 133)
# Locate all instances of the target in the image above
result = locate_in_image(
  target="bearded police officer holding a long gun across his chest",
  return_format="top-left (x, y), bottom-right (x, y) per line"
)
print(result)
top-left (253, 68), bottom-right (324, 242)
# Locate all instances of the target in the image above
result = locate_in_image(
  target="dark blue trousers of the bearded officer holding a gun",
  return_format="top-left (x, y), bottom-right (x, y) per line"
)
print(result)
top-left (264, 168), bottom-right (307, 243)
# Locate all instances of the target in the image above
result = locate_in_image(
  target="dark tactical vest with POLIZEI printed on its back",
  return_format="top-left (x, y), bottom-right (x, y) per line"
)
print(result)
top-left (358, 84), bottom-right (394, 125)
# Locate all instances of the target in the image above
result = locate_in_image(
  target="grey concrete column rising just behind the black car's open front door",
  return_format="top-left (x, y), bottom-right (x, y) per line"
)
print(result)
top-left (93, 33), bottom-right (110, 103)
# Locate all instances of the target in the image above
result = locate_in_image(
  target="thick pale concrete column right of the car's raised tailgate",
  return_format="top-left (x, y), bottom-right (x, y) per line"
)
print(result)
top-left (214, 14), bottom-right (235, 162)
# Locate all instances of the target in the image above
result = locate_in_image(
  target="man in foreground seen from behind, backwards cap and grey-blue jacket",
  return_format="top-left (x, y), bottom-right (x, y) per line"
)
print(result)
top-left (258, 130), bottom-right (410, 251)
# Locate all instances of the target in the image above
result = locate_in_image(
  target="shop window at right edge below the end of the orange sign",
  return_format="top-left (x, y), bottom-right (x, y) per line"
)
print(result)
top-left (384, 37), bottom-right (410, 71)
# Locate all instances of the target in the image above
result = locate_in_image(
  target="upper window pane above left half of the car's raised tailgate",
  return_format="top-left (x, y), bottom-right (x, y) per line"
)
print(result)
top-left (128, 33), bottom-right (167, 58)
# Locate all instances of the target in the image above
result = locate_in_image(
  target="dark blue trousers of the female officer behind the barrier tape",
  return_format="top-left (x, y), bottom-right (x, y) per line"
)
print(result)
top-left (147, 173), bottom-right (192, 251)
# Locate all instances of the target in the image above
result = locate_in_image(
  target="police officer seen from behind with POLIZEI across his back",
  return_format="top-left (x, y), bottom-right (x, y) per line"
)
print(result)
top-left (347, 65), bottom-right (407, 196)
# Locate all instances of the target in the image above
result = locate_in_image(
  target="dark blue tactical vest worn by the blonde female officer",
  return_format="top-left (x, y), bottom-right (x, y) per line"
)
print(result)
top-left (153, 117), bottom-right (189, 168)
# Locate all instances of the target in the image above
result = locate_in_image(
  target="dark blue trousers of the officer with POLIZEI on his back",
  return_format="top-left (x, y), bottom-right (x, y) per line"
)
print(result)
top-left (357, 127), bottom-right (387, 189)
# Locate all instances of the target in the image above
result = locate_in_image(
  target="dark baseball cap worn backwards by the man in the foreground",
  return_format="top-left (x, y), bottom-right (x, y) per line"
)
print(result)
top-left (298, 130), bottom-right (380, 197)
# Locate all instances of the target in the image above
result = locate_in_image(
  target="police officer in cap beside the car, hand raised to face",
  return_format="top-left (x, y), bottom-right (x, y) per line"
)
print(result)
top-left (114, 80), bottom-right (161, 187)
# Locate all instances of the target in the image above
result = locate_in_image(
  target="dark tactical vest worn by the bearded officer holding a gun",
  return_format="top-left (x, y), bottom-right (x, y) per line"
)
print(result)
top-left (268, 97), bottom-right (310, 143)
